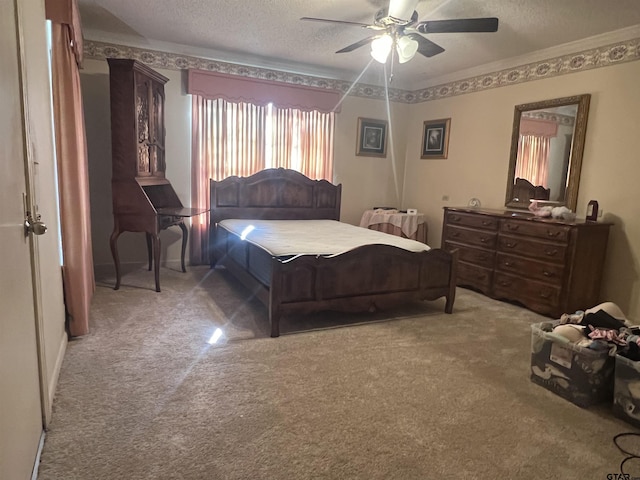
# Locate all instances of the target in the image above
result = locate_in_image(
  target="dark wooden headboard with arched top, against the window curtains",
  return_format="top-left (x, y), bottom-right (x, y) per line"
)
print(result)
top-left (210, 168), bottom-right (342, 226)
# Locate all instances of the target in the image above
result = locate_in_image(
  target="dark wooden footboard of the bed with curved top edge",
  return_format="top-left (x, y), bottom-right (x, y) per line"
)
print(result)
top-left (268, 245), bottom-right (457, 337)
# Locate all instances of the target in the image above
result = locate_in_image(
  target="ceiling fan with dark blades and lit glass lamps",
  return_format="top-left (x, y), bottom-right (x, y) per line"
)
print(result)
top-left (300, 0), bottom-right (498, 63)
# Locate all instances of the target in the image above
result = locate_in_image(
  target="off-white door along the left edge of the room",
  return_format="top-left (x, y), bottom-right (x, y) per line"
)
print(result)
top-left (0, 0), bottom-right (52, 480)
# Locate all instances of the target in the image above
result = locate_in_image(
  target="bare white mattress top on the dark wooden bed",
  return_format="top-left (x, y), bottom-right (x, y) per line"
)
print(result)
top-left (218, 219), bottom-right (430, 257)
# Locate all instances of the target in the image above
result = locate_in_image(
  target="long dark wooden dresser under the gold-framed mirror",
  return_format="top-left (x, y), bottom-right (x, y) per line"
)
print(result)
top-left (442, 207), bottom-right (611, 318)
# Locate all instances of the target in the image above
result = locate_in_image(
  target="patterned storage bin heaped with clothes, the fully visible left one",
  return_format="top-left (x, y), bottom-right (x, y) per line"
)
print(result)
top-left (531, 320), bottom-right (615, 408)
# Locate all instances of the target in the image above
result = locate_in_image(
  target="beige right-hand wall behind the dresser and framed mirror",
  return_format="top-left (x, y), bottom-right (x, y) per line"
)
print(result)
top-left (404, 62), bottom-right (640, 319)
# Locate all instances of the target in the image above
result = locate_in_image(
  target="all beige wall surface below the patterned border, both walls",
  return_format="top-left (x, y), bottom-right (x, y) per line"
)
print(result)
top-left (82, 59), bottom-right (640, 318)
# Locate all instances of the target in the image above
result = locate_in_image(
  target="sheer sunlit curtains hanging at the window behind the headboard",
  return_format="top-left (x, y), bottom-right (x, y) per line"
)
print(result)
top-left (190, 94), bottom-right (335, 265)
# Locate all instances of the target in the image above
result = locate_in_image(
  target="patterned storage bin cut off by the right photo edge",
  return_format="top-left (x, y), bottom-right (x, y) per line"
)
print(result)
top-left (613, 355), bottom-right (640, 427)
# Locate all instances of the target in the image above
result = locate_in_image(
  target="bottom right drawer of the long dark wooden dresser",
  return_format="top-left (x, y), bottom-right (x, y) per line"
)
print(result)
top-left (493, 272), bottom-right (561, 313)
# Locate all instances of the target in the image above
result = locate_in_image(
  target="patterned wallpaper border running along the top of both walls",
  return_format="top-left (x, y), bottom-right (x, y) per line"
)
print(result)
top-left (84, 38), bottom-right (640, 104)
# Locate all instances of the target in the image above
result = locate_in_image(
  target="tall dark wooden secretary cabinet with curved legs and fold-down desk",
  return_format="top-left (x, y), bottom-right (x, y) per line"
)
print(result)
top-left (107, 58), bottom-right (206, 292)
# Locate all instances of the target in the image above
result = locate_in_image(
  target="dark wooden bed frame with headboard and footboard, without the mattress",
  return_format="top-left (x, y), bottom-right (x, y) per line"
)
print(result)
top-left (209, 168), bottom-right (456, 337)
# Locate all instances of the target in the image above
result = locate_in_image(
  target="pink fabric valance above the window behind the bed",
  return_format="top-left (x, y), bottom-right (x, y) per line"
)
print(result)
top-left (187, 70), bottom-right (340, 113)
